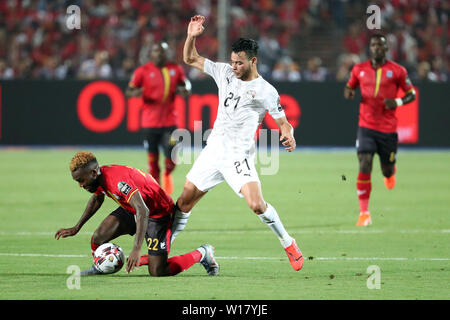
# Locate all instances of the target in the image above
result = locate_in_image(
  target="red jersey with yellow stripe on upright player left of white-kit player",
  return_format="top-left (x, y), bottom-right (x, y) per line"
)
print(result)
top-left (128, 62), bottom-right (186, 128)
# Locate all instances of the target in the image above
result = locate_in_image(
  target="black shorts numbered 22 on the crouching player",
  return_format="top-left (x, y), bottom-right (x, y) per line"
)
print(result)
top-left (110, 207), bottom-right (173, 256)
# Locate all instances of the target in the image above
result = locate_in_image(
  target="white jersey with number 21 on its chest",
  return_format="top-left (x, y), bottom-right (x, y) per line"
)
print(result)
top-left (204, 59), bottom-right (285, 157)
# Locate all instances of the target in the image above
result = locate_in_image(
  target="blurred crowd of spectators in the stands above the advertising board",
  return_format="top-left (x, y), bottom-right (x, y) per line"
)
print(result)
top-left (0, 0), bottom-right (450, 82)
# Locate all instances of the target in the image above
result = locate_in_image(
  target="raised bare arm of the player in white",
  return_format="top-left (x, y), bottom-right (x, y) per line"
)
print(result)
top-left (183, 15), bottom-right (205, 71)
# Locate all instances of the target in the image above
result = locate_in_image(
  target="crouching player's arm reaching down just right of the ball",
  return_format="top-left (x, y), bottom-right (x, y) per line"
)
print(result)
top-left (126, 191), bottom-right (150, 273)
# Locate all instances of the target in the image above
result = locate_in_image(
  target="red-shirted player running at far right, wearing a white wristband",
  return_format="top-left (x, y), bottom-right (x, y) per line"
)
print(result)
top-left (344, 34), bottom-right (416, 226)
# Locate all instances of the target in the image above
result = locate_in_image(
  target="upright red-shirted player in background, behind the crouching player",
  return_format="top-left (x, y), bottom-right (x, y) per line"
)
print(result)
top-left (125, 42), bottom-right (191, 195)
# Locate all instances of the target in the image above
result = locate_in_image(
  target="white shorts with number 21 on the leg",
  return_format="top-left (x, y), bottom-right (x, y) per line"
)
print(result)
top-left (186, 145), bottom-right (260, 198)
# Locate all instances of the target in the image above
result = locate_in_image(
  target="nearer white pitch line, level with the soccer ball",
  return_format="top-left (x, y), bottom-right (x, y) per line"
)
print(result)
top-left (0, 253), bottom-right (450, 261)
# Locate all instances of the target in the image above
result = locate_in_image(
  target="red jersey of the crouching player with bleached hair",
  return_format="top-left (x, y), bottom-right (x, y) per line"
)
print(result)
top-left (95, 165), bottom-right (174, 218)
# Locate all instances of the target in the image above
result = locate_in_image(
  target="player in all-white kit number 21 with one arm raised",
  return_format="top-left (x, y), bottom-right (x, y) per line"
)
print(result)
top-left (172, 15), bottom-right (304, 271)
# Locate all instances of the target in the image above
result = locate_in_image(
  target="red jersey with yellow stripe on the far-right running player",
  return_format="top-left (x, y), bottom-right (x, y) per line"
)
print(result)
top-left (347, 60), bottom-right (413, 133)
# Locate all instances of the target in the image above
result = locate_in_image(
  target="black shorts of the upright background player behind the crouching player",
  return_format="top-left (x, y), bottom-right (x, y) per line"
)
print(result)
top-left (142, 126), bottom-right (178, 158)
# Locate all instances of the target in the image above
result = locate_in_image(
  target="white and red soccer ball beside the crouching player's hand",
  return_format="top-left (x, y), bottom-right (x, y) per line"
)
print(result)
top-left (94, 243), bottom-right (125, 273)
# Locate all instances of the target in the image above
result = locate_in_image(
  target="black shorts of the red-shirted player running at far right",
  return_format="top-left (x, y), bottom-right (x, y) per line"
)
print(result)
top-left (356, 127), bottom-right (398, 164)
